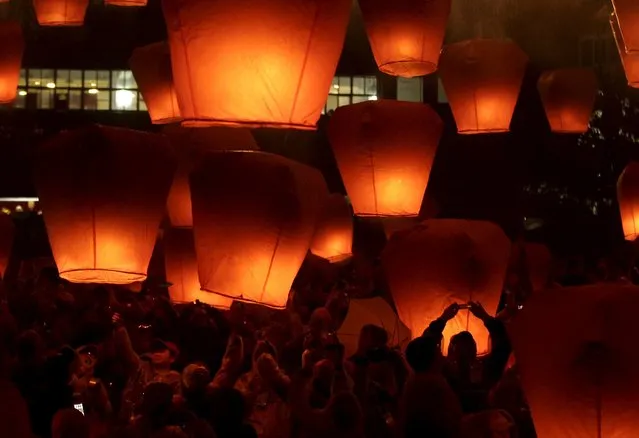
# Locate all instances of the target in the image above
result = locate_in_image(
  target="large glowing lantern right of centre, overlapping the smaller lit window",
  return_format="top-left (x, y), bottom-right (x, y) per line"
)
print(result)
top-left (328, 100), bottom-right (443, 216)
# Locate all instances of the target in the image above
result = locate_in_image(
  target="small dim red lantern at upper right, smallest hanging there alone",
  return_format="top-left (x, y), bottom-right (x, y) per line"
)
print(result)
top-left (537, 68), bottom-right (597, 134)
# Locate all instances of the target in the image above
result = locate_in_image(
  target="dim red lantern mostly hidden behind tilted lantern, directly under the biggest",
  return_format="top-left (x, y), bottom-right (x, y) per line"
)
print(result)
top-left (163, 126), bottom-right (259, 228)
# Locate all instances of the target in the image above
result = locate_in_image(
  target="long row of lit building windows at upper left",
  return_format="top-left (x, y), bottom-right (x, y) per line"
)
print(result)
top-left (14, 69), bottom-right (146, 111)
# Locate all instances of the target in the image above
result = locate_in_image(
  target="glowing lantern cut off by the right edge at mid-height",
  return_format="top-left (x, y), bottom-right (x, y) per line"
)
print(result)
top-left (617, 161), bottom-right (639, 240)
